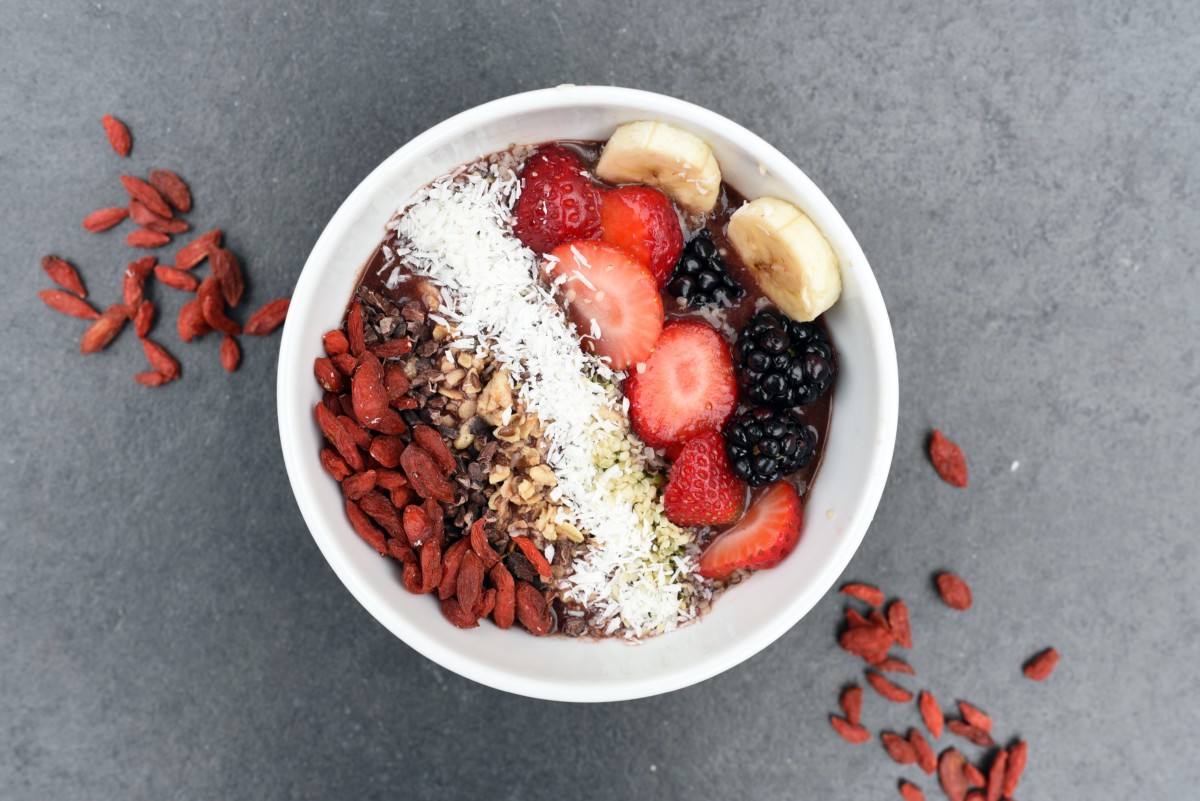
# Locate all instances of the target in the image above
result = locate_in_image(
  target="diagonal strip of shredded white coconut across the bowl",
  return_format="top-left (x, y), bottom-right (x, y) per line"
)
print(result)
top-left (390, 163), bottom-right (696, 637)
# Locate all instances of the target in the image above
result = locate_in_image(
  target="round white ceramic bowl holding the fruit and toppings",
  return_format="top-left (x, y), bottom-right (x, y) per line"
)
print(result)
top-left (278, 86), bottom-right (898, 701)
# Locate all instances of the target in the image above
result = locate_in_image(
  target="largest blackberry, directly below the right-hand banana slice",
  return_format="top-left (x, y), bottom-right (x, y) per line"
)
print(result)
top-left (737, 309), bottom-right (838, 409)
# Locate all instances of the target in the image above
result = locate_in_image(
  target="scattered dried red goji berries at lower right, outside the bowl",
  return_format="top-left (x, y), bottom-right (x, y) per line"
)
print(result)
top-left (829, 565), bottom-right (1058, 801)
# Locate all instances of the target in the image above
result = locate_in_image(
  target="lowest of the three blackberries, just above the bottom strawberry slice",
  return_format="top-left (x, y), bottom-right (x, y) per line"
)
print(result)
top-left (725, 406), bottom-right (817, 487)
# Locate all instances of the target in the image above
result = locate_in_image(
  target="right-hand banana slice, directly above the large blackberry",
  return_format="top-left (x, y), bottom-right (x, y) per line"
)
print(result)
top-left (728, 198), bottom-right (841, 323)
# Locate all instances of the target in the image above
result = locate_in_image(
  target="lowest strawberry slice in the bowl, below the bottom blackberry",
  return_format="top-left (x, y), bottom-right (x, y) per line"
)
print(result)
top-left (700, 481), bottom-right (802, 579)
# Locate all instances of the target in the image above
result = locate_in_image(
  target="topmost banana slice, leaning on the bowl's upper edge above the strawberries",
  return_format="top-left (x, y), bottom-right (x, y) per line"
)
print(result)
top-left (595, 121), bottom-right (721, 213)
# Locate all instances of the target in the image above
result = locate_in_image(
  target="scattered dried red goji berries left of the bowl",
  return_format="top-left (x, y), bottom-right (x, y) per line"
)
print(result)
top-left (38, 115), bottom-right (288, 386)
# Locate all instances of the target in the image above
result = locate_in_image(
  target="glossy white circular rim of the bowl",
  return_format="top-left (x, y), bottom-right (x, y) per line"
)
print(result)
top-left (276, 84), bottom-right (899, 701)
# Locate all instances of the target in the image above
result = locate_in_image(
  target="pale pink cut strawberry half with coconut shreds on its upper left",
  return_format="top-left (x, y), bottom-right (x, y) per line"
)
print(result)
top-left (545, 242), bottom-right (662, 369)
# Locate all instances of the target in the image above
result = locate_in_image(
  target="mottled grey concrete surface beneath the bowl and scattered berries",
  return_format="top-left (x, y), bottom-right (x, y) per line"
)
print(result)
top-left (0, 0), bottom-right (1200, 801)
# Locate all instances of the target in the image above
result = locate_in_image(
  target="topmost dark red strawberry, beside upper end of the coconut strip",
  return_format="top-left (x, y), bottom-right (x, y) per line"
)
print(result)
top-left (514, 145), bottom-right (600, 253)
